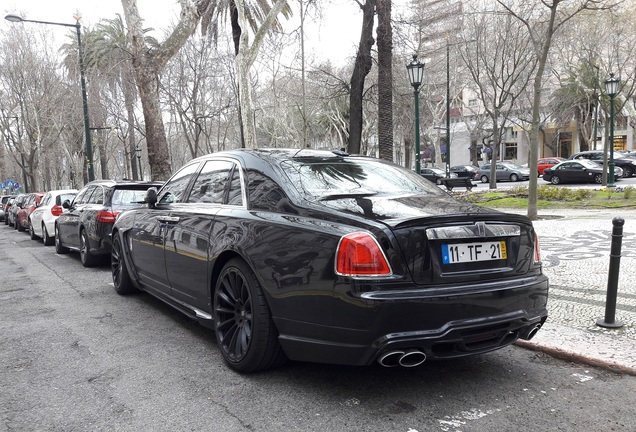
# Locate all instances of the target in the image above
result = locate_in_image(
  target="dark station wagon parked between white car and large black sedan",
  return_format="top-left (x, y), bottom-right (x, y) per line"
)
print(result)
top-left (55, 180), bottom-right (162, 267)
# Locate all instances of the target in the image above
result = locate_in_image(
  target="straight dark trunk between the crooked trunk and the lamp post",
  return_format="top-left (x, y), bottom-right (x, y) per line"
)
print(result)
top-left (376, 0), bottom-right (393, 161)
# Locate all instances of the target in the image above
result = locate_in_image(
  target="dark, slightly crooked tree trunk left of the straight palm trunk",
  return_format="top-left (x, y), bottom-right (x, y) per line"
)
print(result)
top-left (347, 0), bottom-right (375, 153)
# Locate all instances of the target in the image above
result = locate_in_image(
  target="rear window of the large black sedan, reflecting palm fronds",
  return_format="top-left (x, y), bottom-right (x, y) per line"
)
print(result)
top-left (283, 158), bottom-right (443, 199)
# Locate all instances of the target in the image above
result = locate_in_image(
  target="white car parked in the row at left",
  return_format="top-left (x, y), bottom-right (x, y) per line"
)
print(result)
top-left (29, 189), bottom-right (77, 246)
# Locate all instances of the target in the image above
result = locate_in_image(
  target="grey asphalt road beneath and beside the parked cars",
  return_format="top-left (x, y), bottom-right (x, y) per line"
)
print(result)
top-left (0, 225), bottom-right (636, 432)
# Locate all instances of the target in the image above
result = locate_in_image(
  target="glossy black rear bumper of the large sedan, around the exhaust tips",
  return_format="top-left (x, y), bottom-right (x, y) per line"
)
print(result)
top-left (276, 275), bottom-right (548, 365)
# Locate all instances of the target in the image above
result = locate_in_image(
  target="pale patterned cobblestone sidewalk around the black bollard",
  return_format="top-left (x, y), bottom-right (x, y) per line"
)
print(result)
top-left (510, 209), bottom-right (636, 375)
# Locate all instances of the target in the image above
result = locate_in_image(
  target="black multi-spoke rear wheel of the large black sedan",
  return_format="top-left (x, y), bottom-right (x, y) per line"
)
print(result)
top-left (213, 258), bottom-right (286, 372)
